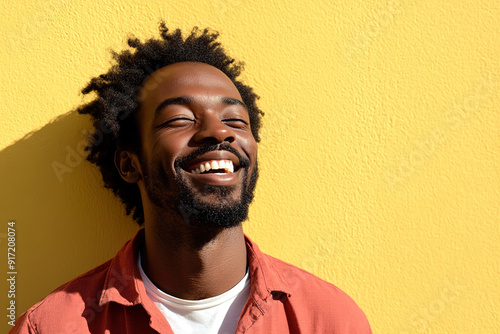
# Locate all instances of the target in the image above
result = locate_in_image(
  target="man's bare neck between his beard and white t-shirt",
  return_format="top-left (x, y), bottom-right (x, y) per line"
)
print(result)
top-left (142, 217), bottom-right (247, 300)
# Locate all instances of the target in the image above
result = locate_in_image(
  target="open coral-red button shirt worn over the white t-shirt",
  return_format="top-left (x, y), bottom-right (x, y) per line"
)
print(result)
top-left (10, 230), bottom-right (371, 334)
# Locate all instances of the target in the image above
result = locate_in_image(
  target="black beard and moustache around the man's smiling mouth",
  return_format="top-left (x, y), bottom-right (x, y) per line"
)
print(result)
top-left (141, 144), bottom-right (259, 229)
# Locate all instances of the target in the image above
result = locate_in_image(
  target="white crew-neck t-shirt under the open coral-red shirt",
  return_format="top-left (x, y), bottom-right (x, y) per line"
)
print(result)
top-left (137, 254), bottom-right (250, 334)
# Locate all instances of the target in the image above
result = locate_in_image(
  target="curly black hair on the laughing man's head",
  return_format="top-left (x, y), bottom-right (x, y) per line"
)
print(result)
top-left (76, 21), bottom-right (263, 226)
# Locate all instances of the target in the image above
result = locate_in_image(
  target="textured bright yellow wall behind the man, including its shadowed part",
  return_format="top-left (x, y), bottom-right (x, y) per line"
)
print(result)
top-left (0, 0), bottom-right (500, 334)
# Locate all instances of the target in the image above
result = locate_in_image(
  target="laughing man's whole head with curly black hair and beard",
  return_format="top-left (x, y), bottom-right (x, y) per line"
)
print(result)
top-left (78, 23), bottom-right (262, 226)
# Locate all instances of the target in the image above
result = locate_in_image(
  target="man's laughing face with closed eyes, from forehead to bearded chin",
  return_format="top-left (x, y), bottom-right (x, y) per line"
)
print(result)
top-left (137, 62), bottom-right (258, 227)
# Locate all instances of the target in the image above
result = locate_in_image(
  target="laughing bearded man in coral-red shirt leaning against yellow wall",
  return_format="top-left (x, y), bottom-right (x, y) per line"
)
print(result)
top-left (11, 23), bottom-right (371, 334)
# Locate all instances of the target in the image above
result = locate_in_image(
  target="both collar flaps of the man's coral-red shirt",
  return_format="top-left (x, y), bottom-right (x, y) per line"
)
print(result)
top-left (99, 229), bottom-right (290, 307)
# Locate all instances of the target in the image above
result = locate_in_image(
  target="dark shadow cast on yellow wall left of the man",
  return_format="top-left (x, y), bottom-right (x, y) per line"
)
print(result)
top-left (0, 112), bottom-right (138, 320)
